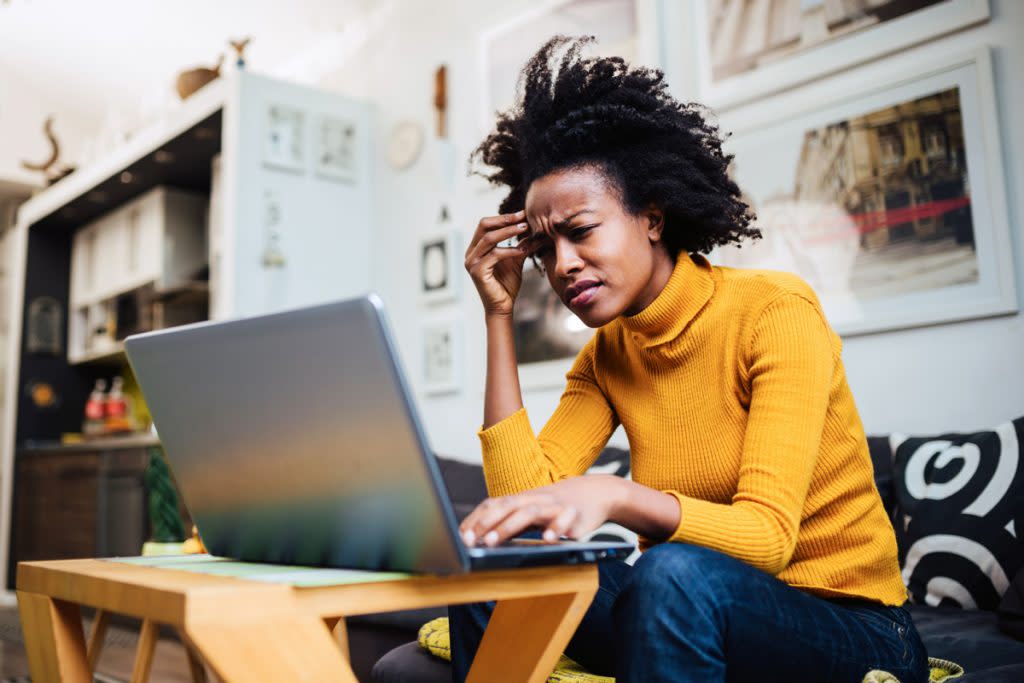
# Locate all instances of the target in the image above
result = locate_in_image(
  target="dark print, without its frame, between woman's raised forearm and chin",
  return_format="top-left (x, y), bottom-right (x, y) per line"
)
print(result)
top-left (512, 261), bottom-right (594, 368)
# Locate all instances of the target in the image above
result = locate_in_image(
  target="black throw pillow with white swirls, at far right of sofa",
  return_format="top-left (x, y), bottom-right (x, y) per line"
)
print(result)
top-left (890, 418), bottom-right (1024, 610)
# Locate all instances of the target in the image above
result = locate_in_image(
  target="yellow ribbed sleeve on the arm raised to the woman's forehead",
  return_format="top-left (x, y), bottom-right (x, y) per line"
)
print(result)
top-left (478, 339), bottom-right (618, 497)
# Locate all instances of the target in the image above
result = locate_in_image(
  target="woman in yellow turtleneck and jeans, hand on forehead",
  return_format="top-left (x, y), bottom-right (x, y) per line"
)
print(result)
top-left (450, 37), bottom-right (928, 683)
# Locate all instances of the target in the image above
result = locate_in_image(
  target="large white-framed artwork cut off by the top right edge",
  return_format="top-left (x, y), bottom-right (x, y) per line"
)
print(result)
top-left (693, 0), bottom-right (989, 110)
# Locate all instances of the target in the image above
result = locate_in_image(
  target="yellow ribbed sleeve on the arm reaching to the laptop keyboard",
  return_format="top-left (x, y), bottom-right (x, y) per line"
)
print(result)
top-left (668, 293), bottom-right (836, 574)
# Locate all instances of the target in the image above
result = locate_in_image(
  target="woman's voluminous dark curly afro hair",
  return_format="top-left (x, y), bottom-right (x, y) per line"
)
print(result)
top-left (470, 36), bottom-right (761, 255)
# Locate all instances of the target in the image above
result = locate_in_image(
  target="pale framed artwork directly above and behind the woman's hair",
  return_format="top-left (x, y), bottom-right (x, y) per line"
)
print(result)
top-left (478, 0), bottom-right (660, 131)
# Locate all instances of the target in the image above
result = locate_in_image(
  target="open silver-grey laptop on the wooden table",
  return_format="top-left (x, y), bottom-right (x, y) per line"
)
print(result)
top-left (125, 294), bottom-right (633, 573)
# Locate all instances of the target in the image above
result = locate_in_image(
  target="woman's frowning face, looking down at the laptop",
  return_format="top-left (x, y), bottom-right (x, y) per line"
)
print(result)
top-left (526, 167), bottom-right (674, 328)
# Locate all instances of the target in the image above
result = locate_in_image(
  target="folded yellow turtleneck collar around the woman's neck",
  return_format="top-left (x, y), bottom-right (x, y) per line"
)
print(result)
top-left (620, 252), bottom-right (715, 346)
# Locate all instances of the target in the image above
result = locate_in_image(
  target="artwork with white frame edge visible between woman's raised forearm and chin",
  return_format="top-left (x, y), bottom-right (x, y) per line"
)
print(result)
top-left (513, 261), bottom-right (594, 389)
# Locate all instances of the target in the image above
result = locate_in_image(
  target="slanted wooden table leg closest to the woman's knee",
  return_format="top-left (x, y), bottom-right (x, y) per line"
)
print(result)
top-left (466, 588), bottom-right (596, 683)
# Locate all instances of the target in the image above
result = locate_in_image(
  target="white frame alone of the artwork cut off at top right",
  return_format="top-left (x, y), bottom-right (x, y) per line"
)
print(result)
top-left (691, 0), bottom-right (990, 112)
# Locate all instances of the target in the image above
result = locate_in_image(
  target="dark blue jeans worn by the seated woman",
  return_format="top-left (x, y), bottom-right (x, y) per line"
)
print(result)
top-left (449, 543), bottom-right (928, 683)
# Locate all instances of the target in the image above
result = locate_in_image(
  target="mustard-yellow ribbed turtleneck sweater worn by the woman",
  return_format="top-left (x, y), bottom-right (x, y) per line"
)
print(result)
top-left (479, 254), bottom-right (906, 605)
